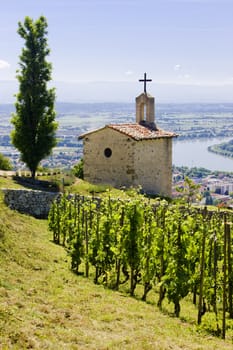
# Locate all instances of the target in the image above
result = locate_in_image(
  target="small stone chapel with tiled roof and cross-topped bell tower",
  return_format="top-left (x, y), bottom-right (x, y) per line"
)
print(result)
top-left (79, 73), bottom-right (177, 197)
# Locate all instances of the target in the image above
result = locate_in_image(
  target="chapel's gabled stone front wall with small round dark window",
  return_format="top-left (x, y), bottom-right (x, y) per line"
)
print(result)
top-left (84, 128), bottom-right (135, 188)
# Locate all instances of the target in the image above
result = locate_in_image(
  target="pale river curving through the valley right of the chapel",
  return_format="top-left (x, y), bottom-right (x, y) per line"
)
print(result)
top-left (173, 137), bottom-right (233, 171)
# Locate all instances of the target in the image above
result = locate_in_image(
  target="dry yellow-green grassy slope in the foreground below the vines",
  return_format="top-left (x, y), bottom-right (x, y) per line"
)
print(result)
top-left (0, 178), bottom-right (232, 350)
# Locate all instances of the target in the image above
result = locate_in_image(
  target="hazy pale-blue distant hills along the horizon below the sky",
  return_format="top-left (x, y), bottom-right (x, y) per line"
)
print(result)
top-left (0, 79), bottom-right (232, 104)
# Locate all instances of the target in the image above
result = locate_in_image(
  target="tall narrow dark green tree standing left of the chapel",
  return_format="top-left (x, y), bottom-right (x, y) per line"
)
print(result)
top-left (11, 16), bottom-right (58, 178)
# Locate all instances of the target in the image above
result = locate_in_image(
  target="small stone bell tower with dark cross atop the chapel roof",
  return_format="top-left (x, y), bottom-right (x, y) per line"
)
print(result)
top-left (136, 73), bottom-right (157, 130)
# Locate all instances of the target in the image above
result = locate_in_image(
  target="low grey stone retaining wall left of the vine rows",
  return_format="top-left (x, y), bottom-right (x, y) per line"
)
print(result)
top-left (3, 189), bottom-right (61, 218)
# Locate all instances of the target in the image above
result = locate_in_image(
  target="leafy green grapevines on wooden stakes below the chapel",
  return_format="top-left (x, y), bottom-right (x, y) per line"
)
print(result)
top-left (49, 195), bottom-right (233, 338)
